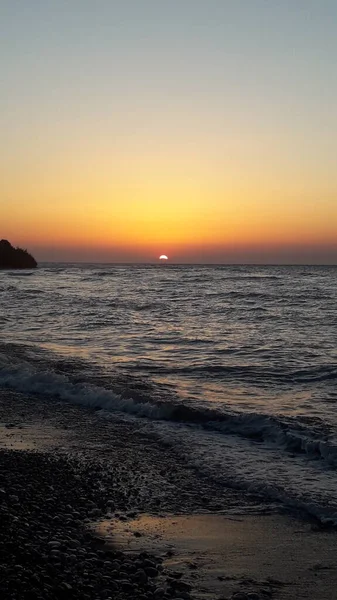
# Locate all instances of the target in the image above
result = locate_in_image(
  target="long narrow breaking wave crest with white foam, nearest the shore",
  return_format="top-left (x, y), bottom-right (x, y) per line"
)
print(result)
top-left (0, 354), bottom-right (337, 466)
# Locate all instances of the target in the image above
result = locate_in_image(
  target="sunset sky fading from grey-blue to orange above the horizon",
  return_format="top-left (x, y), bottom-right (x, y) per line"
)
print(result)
top-left (0, 0), bottom-right (337, 264)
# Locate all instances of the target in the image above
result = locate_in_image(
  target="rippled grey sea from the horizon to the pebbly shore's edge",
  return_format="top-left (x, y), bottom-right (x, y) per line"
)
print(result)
top-left (0, 264), bottom-right (337, 523)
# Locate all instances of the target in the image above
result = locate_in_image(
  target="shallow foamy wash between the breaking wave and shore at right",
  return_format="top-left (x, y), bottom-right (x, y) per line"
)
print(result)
top-left (126, 422), bottom-right (337, 525)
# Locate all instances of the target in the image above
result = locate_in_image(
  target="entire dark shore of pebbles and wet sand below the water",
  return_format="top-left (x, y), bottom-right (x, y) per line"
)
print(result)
top-left (0, 390), bottom-right (337, 600)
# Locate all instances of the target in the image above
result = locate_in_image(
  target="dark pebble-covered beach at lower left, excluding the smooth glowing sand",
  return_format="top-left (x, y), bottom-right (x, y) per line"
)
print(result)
top-left (0, 391), bottom-right (251, 600)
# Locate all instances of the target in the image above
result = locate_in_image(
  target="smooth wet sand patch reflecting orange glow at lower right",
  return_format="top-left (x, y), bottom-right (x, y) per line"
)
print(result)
top-left (96, 514), bottom-right (337, 600)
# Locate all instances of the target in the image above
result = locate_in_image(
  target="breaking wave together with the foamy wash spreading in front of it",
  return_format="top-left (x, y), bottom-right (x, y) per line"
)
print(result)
top-left (0, 344), bottom-right (337, 524)
